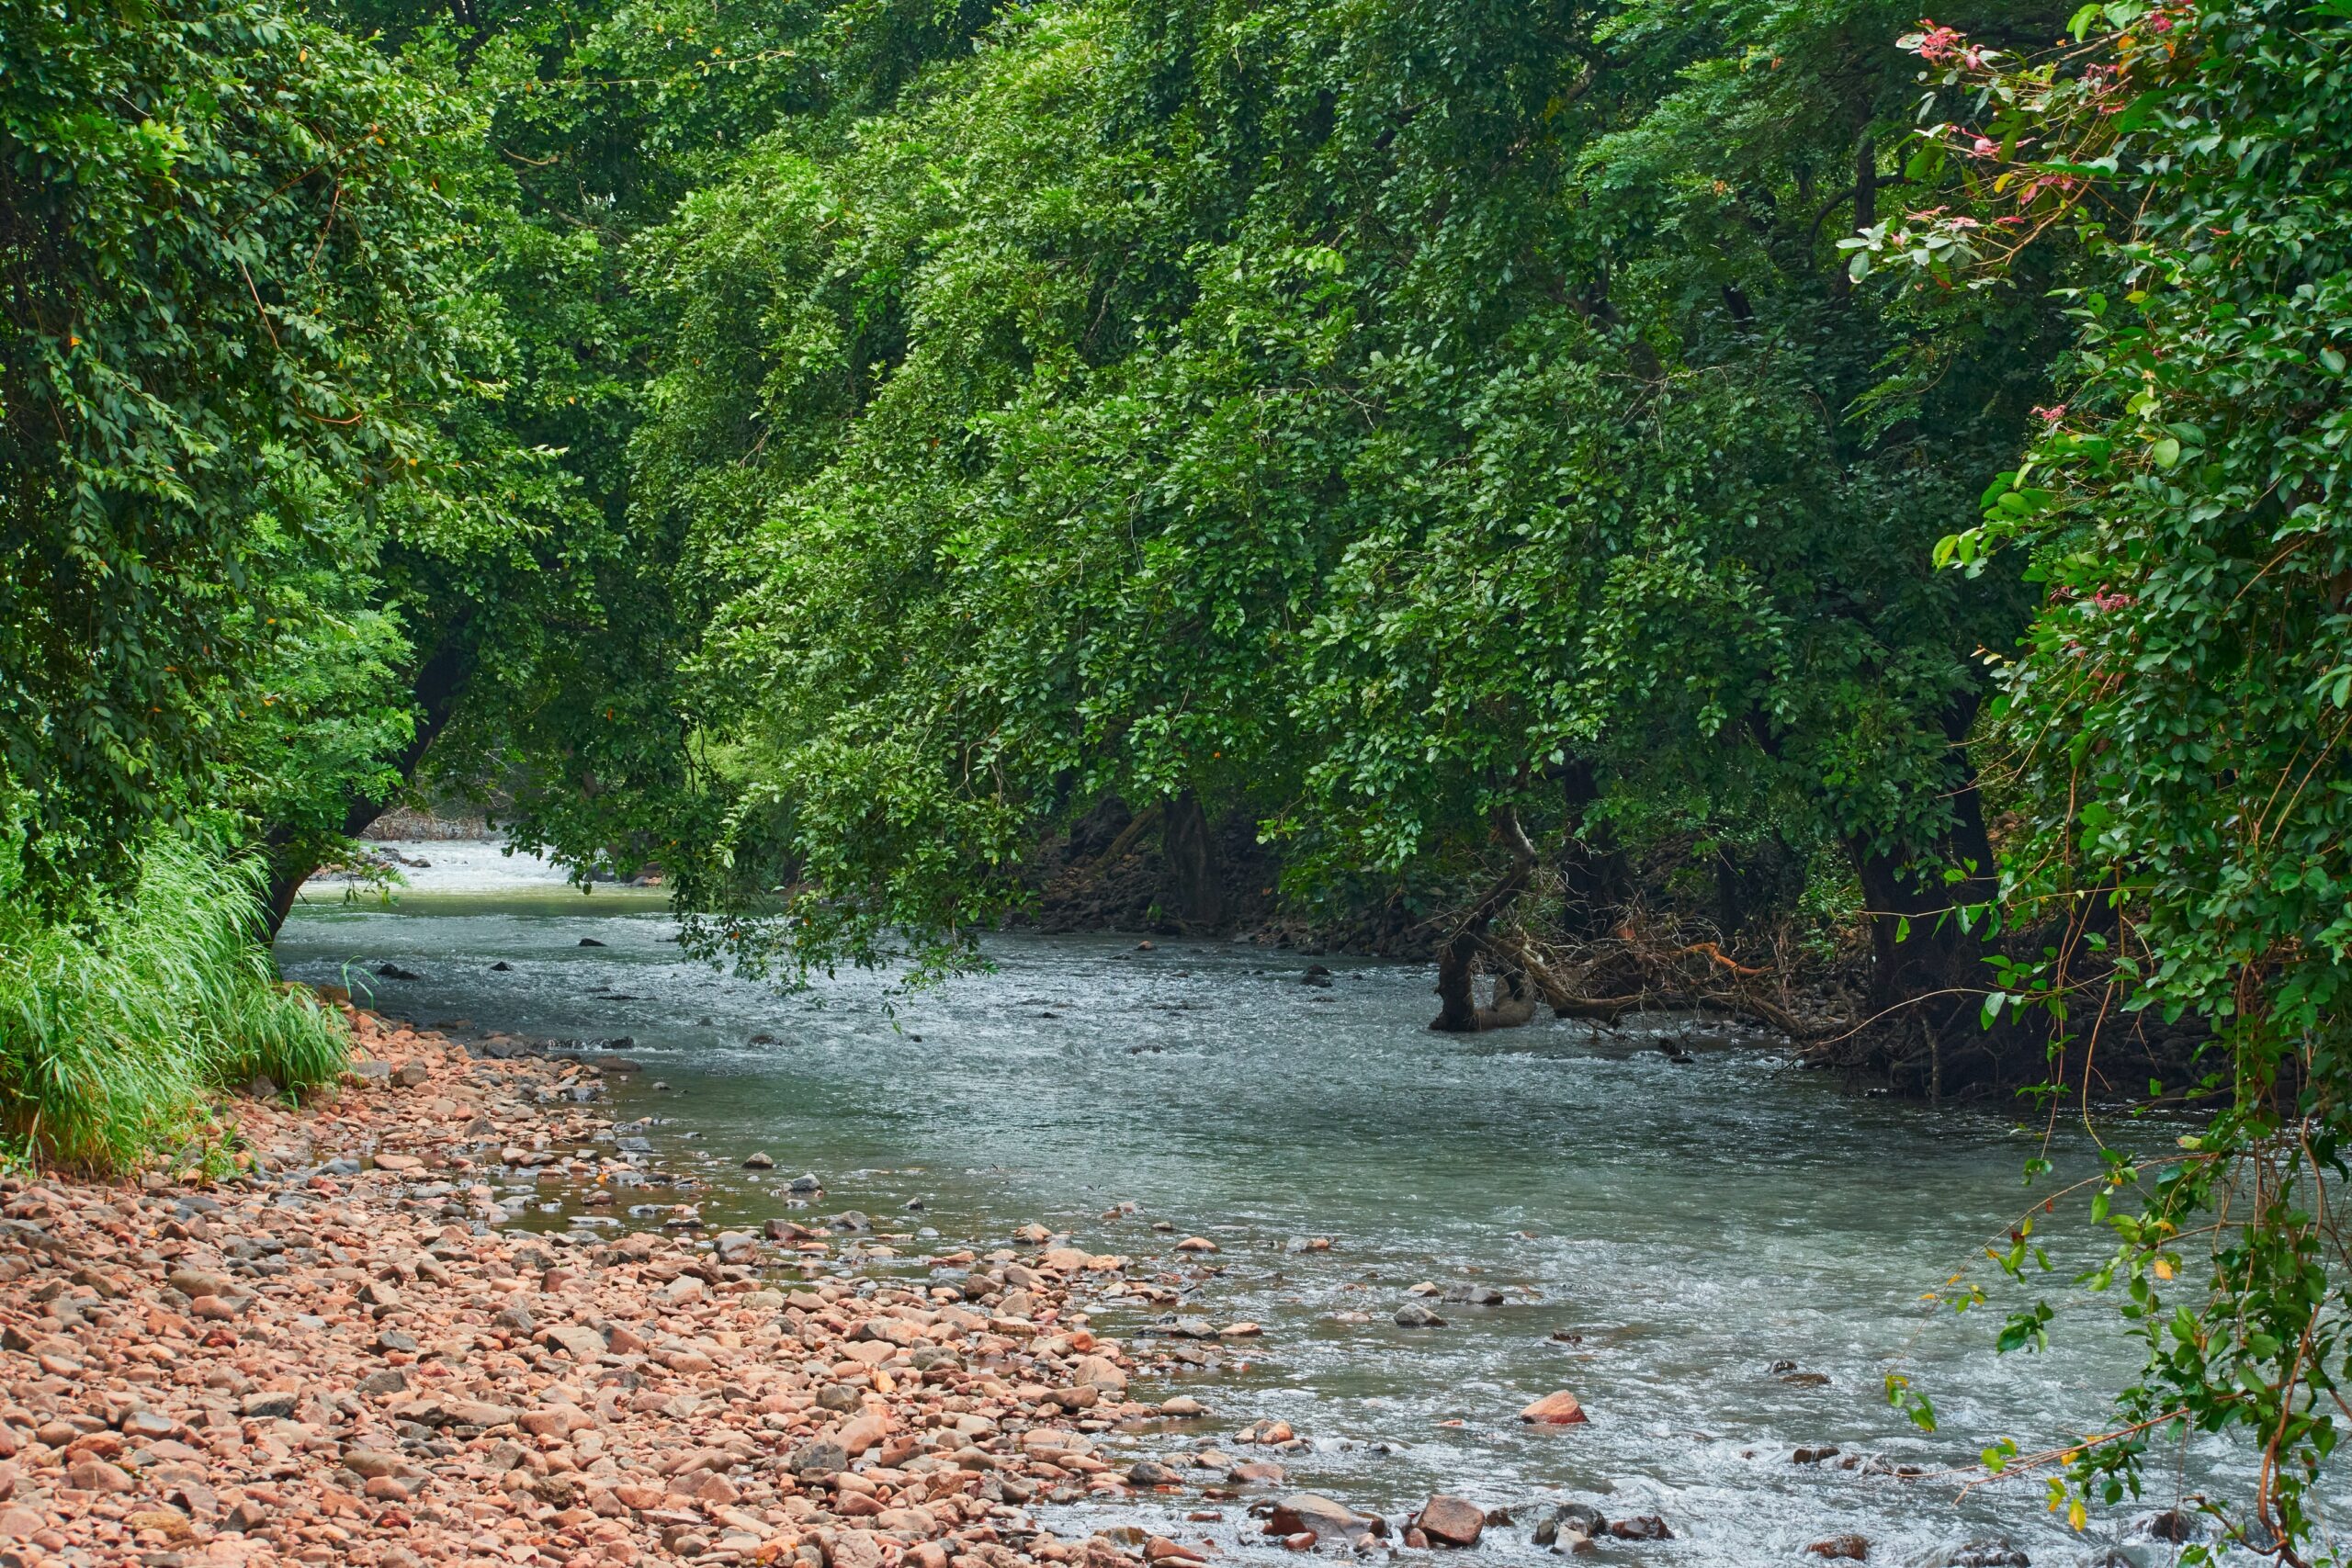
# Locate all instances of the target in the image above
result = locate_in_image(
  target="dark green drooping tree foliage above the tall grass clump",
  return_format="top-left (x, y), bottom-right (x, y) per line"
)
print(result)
top-left (0, 0), bottom-right (480, 900)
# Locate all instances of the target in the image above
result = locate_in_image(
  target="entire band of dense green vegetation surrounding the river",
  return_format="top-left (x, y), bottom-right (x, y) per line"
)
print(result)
top-left (0, 0), bottom-right (2352, 1550)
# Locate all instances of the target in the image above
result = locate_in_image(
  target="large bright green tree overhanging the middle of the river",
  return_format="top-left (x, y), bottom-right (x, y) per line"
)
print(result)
top-left (638, 3), bottom-right (2055, 999)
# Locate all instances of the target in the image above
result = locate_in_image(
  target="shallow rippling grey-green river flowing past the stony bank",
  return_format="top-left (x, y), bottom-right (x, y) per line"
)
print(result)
top-left (277, 844), bottom-right (2242, 1565)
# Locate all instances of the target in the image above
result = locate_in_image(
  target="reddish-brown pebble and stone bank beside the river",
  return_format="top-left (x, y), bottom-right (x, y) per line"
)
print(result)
top-left (0, 1013), bottom-right (1250, 1568)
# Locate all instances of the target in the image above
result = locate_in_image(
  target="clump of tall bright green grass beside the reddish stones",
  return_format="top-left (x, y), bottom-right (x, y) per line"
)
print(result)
top-left (0, 840), bottom-right (350, 1170)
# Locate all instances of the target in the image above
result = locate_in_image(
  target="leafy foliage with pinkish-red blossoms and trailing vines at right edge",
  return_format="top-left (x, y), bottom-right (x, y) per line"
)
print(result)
top-left (1856, 0), bottom-right (2352, 1561)
